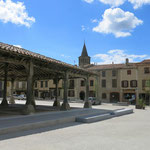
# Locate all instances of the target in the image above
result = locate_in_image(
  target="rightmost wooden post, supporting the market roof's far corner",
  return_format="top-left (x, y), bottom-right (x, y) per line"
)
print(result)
top-left (84, 75), bottom-right (92, 108)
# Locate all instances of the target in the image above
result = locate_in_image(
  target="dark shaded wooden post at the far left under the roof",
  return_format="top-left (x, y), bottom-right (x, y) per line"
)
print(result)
top-left (1, 63), bottom-right (8, 106)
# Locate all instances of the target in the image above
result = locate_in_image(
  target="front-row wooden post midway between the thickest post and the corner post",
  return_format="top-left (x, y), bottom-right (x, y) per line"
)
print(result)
top-left (61, 71), bottom-right (70, 110)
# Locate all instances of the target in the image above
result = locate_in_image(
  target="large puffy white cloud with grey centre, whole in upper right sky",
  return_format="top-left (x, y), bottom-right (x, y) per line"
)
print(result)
top-left (93, 8), bottom-right (143, 37)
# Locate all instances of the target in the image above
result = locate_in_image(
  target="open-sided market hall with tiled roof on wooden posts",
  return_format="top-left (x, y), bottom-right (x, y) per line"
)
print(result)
top-left (0, 43), bottom-right (98, 114)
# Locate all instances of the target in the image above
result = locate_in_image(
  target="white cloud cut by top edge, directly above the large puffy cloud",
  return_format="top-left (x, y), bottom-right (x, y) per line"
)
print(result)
top-left (99, 0), bottom-right (126, 7)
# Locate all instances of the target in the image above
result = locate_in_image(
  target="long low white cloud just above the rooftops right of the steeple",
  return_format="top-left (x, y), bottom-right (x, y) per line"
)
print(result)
top-left (93, 49), bottom-right (149, 64)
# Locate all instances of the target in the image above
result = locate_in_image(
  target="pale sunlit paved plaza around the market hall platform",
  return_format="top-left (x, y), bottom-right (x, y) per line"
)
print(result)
top-left (0, 101), bottom-right (150, 150)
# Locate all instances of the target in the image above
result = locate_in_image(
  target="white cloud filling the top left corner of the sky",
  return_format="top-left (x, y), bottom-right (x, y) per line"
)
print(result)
top-left (0, 0), bottom-right (35, 27)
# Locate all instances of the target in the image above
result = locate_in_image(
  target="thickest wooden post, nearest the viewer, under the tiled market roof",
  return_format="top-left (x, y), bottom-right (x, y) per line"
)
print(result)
top-left (23, 61), bottom-right (35, 114)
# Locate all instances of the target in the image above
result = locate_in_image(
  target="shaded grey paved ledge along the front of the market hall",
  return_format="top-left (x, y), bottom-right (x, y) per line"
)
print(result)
top-left (0, 108), bottom-right (112, 134)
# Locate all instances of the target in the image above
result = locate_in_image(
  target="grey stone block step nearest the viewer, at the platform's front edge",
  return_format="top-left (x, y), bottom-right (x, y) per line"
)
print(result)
top-left (76, 113), bottom-right (112, 123)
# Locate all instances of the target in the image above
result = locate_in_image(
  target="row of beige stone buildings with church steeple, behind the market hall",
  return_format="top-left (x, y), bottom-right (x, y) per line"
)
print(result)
top-left (0, 43), bottom-right (150, 104)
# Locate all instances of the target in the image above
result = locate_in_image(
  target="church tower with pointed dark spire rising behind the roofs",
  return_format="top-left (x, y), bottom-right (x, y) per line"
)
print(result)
top-left (79, 42), bottom-right (91, 67)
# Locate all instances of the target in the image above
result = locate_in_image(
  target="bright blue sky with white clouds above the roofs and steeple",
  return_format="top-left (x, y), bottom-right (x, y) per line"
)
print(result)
top-left (0, 0), bottom-right (150, 64)
